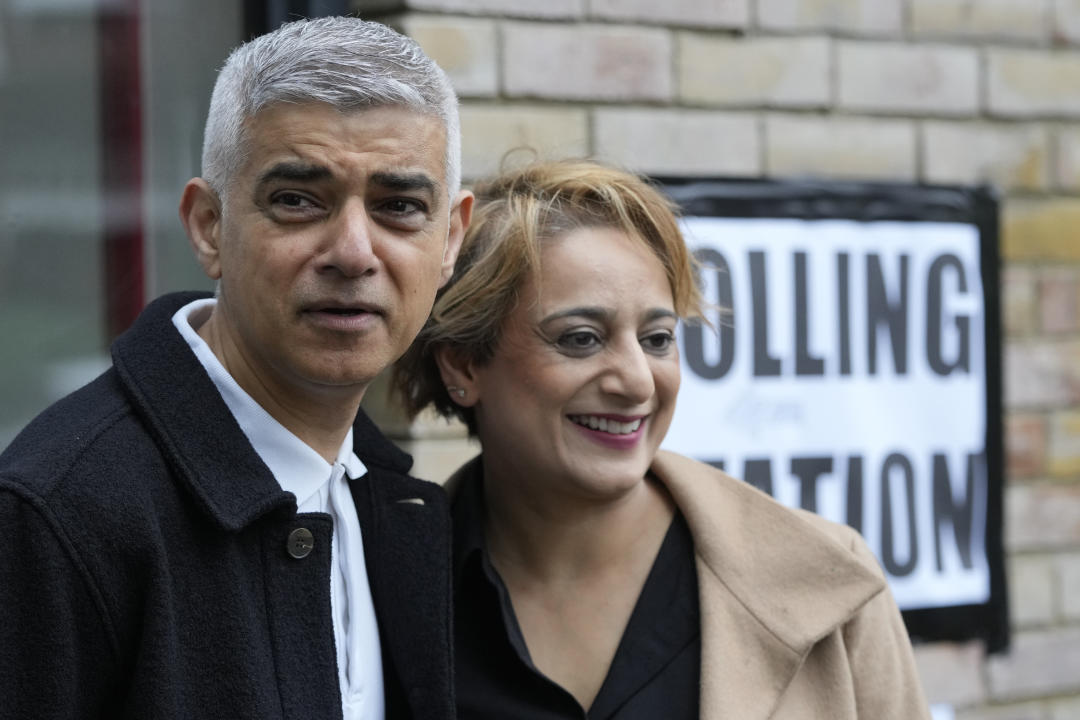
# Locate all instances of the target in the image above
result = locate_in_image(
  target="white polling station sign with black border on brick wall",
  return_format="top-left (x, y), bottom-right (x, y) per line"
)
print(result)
top-left (664, 181), bottom-right (1008, 649)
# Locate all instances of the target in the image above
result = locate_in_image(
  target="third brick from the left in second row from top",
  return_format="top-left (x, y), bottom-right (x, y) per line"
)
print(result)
top-left (677, 32), bottom-right (829, 108)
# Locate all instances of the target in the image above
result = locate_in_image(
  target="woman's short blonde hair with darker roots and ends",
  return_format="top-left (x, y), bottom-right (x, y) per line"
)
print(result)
top-left (393, 160), bottom-right (703, 433)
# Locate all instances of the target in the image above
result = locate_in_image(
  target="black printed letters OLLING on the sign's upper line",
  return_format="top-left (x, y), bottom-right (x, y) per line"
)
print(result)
top-left (683, 247), bottom-right (972, 380)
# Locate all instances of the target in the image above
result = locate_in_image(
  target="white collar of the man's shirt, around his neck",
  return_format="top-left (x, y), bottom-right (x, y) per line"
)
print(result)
top-left (173, 298), bottom-right (367, 505)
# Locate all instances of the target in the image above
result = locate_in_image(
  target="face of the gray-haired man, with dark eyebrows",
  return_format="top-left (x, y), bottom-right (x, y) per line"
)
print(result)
top-left (181, 104), bottom-right (469, 403)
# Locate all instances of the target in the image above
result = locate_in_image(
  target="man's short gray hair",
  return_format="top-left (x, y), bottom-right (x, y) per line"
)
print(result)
top-left (202, 17), bottom-right (461, 200)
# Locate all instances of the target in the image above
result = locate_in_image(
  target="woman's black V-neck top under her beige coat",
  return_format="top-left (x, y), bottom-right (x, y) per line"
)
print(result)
top-left (453, 462), bottom-right (701, 720)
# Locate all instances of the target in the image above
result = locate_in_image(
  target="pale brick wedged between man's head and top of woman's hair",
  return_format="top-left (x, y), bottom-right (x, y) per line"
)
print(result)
top-left (461, 103), bottom-right (589, 179)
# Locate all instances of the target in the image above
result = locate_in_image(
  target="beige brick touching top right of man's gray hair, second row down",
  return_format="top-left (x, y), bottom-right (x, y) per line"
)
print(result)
top-left (402, 14), bottom-right (499, 97)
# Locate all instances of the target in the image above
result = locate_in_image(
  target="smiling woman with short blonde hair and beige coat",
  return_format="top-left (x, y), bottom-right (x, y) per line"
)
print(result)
top-left (396, 162), bottom-right (929, 720)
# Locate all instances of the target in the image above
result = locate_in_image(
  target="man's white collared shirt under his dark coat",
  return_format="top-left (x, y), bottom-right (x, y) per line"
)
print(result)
top-left (173, 298), bottom-right (386, 720)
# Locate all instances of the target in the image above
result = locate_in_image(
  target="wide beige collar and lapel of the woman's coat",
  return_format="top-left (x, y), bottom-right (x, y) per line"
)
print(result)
top-left (652, 451), bottom-right (885, 720)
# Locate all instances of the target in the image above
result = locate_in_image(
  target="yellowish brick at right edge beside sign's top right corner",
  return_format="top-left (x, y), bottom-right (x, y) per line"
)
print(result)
top-left (1001, 198), bottom-right (1080, 261)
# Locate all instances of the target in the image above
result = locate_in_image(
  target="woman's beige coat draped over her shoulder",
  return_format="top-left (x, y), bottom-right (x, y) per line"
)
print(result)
top-left (652, 451), bottom-right (930, 720)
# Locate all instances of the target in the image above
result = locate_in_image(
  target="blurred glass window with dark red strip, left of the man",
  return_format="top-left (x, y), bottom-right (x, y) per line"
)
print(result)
top-left (0, 0), bottom-right (244, 449)
